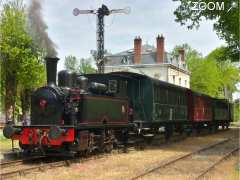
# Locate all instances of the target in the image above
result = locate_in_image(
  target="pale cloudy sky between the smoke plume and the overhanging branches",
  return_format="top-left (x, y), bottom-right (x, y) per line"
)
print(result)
top-left (32, 0), bottom-right (227, 70)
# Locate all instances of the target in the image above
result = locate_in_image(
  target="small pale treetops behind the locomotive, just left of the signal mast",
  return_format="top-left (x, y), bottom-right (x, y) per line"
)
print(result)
top-left (64, 55), bottom-right (96, 74)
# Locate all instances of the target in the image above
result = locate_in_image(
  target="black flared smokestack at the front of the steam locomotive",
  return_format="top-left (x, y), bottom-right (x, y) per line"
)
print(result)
top-left (45, 57), bottom-right (59, 85)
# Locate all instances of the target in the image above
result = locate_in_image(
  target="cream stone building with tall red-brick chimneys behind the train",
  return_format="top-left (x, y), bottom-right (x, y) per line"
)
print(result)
top-left (105, 36), bottom-right (190, 88)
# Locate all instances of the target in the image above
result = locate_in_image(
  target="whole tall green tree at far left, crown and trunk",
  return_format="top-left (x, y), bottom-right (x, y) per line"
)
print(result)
top-left (0, 0), bottom-right (45, 120)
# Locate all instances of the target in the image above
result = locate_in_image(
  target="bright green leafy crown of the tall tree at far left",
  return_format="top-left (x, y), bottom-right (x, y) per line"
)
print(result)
top-left (0, 0), bottom-right (45, 88)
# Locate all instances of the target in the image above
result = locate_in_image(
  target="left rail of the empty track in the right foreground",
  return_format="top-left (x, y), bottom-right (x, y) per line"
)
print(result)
top-left (131, 138), bottom-right (234, 180)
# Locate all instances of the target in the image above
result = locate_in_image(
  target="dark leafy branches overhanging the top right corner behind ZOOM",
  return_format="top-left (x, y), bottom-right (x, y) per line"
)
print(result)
top-left (174, 0), bottom-right (240, 61)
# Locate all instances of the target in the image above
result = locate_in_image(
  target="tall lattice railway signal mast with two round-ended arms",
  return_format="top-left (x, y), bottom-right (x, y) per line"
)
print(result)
top-left (73, 4), bottom-right (130, 73)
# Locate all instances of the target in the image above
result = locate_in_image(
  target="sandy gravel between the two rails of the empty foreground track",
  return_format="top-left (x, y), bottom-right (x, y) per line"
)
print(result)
top-left (141, 140), bottom-right (238, 180)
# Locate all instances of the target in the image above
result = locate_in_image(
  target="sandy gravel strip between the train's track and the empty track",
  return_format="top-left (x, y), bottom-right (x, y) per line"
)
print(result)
top-left (9, 128), bottom-right (239, 180)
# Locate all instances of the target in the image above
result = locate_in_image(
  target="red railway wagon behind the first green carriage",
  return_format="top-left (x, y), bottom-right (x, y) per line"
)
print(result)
top-left (188, 90), bottom-right (212, 122)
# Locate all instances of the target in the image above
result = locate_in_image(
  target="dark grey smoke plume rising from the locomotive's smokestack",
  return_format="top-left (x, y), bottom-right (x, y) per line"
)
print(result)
top-left (28, 0), bottom-right (57, 57)
